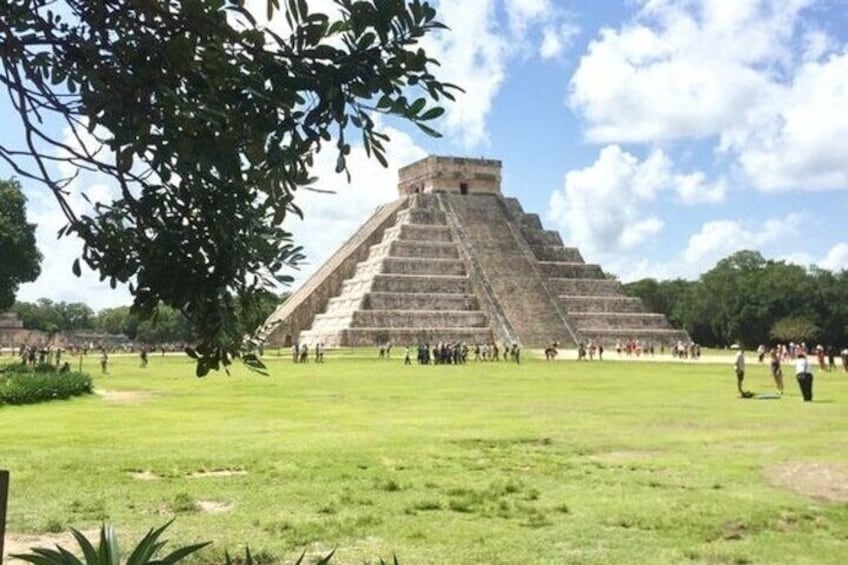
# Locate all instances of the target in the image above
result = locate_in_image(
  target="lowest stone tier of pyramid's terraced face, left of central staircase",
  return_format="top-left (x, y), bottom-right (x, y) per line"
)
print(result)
top-left (308, 328), bottom-right (492, 346)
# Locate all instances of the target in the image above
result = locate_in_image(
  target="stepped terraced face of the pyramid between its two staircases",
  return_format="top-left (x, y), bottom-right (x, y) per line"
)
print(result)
top-left (300, 195), bottom-right (492, 347)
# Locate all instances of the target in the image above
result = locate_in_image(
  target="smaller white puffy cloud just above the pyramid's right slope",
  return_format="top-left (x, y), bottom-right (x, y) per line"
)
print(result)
top-left (548, 145), bottom-right (725, 253)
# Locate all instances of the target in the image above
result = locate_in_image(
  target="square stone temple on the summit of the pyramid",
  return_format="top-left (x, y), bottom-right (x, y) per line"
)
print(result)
top-left (398, 155), bottom-right (501, 196)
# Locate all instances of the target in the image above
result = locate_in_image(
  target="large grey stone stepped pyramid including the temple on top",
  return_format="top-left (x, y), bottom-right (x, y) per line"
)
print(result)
top-left (260, 156), bottom-right (689, 347)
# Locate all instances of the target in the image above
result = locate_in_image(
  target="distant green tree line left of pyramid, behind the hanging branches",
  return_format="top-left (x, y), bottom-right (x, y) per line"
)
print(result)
top-left (13, 291), bottom-right (288, 344)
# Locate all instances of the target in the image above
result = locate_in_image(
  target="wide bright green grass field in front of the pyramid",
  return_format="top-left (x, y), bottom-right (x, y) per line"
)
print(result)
top-left (0, 351), bottom-right (848, 564)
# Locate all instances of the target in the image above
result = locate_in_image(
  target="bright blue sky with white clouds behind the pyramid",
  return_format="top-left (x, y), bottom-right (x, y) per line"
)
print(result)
top-left (6, 0), bottom-right (848, 309)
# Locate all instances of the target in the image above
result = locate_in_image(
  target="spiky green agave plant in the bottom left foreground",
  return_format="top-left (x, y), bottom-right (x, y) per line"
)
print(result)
top-left (12, 520), bottom-right (212, 565)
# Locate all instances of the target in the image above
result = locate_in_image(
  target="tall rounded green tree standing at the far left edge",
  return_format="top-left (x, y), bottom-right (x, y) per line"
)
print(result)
top-left (0, 180), bottom-right (41, 311)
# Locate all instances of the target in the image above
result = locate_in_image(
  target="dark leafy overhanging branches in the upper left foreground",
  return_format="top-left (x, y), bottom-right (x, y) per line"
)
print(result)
top-left (0, 0), bottom-right (459, 375)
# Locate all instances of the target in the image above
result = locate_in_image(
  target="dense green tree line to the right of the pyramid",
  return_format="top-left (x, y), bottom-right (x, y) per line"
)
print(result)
top-left (624, 251), bottom-right (848, 347)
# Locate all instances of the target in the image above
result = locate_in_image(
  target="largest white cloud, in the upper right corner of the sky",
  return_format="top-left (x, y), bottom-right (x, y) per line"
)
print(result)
top-left (568, 0), bottom-right (848, 190)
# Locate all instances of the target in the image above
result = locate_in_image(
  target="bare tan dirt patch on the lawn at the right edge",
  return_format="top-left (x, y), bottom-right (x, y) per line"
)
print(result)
top-left (763, 461), bottom-right (848, 502)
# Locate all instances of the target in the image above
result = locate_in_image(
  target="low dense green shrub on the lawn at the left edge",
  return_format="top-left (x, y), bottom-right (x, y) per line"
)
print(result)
top-left (0, 365), bottom-right (92, 405)
